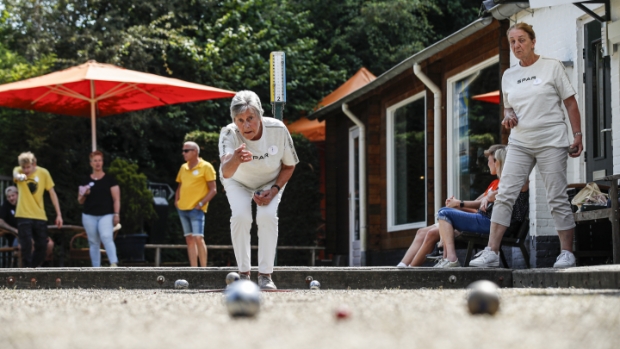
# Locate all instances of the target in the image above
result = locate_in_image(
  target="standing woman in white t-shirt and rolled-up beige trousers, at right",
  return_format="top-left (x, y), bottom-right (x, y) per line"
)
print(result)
top-left (470, 23), bottom-right (583, 268)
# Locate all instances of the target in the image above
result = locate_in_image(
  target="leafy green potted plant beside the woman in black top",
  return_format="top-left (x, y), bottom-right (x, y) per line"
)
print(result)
top-left (108, 159), bottom-right (157, 262)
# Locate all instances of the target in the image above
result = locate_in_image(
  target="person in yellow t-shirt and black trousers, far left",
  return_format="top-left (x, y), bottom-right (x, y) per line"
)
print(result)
top-left (13, 152), bottom-right (62, 268)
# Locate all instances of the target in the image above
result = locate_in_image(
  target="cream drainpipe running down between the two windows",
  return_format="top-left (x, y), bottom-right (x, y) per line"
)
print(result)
top-left (413, 63), bottom-right (443, 212)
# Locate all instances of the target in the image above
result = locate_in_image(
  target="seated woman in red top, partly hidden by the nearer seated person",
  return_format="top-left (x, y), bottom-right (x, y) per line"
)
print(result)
top-left (397, 144), bottom-right (506, 268)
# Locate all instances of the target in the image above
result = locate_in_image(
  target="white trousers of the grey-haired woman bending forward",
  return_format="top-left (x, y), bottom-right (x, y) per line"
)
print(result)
top-left (225, 180), bottom-right (284, 274)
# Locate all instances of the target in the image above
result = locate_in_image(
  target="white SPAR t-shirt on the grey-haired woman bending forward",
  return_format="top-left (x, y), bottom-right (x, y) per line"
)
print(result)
top-left (219, 117), bottom-right (299, 190)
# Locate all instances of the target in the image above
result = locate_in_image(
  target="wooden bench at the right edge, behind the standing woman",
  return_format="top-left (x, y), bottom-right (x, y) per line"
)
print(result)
top-left (569, 174), bottom-right (620, 264)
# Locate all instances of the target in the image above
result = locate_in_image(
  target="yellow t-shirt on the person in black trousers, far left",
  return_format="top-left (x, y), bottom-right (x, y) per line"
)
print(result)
top-left (13, 166), bottom-right (54, 221)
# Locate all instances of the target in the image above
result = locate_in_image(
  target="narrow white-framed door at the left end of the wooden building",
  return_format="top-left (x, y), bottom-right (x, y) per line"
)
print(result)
top-left (349, 126), bottom-right (362, 267)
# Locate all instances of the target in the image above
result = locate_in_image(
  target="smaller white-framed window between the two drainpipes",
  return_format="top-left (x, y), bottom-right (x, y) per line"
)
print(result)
top-left (387, 92), bottom-right (427, 231)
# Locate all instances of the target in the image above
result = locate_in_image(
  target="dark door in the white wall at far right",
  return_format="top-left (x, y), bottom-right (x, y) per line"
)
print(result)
top-left (583, 21), bottom-right (613, 182)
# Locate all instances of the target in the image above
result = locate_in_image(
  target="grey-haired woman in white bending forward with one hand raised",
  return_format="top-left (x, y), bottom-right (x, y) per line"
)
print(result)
top-left (219, 91), bottom-right (299, 289)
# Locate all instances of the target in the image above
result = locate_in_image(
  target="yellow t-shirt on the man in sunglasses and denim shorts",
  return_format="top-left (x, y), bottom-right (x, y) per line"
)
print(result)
top-left (177, 159), bottom-right (216, 212)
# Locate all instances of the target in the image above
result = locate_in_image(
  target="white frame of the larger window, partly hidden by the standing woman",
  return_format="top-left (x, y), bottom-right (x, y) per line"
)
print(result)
top-left (446, 55), bottom-right (501, 197)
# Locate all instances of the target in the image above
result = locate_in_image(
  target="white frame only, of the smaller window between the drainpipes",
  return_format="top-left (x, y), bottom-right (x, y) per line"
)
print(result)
top-left (386, 91), bottom-right (428, 232)
